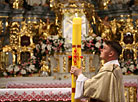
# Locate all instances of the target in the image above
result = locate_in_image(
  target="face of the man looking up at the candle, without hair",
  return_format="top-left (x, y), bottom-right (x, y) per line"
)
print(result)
top-left (100, 43), bottom-right (111, 62)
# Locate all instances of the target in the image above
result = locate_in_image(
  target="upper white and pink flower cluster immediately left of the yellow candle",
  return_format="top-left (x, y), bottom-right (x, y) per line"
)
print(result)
top-left (36, 35), bottom-right (71, 55)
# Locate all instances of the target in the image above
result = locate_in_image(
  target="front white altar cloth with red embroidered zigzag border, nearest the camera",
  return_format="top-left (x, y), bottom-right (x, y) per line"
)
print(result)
top-left (0, 88), bottom-right (71, 102)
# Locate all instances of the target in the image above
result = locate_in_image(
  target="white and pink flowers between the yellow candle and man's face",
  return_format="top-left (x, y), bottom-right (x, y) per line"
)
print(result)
top-left (82, 35), bottom-right (103, 53)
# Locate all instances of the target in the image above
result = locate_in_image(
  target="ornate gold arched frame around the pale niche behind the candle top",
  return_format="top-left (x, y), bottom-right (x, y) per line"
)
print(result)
top-left (50, 0), bottom-right (95, 36)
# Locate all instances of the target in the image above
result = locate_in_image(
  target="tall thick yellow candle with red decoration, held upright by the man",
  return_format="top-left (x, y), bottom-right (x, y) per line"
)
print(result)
top-left (71, 17), bottom-right (82, 102)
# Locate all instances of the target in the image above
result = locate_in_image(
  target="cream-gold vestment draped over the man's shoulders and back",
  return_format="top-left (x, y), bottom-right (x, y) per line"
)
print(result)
top-left (76, 64), bottom-right (125, 102)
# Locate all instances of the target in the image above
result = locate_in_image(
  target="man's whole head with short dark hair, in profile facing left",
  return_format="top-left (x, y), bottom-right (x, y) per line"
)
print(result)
top-left (100, 40), bottom-right (122, 62)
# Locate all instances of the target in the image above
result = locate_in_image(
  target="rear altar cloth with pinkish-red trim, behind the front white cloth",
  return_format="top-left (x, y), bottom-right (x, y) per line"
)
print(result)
top-left (6, 80), bottom-right (71, 88)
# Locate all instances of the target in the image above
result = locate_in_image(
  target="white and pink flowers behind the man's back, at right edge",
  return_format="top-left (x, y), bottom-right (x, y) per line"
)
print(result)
top-left (120, 59), bottom-right (138, 74)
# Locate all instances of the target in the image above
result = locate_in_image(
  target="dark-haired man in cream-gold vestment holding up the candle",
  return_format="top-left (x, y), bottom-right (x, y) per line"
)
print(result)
top-left (70, 41), bottom-right (125, 102)
